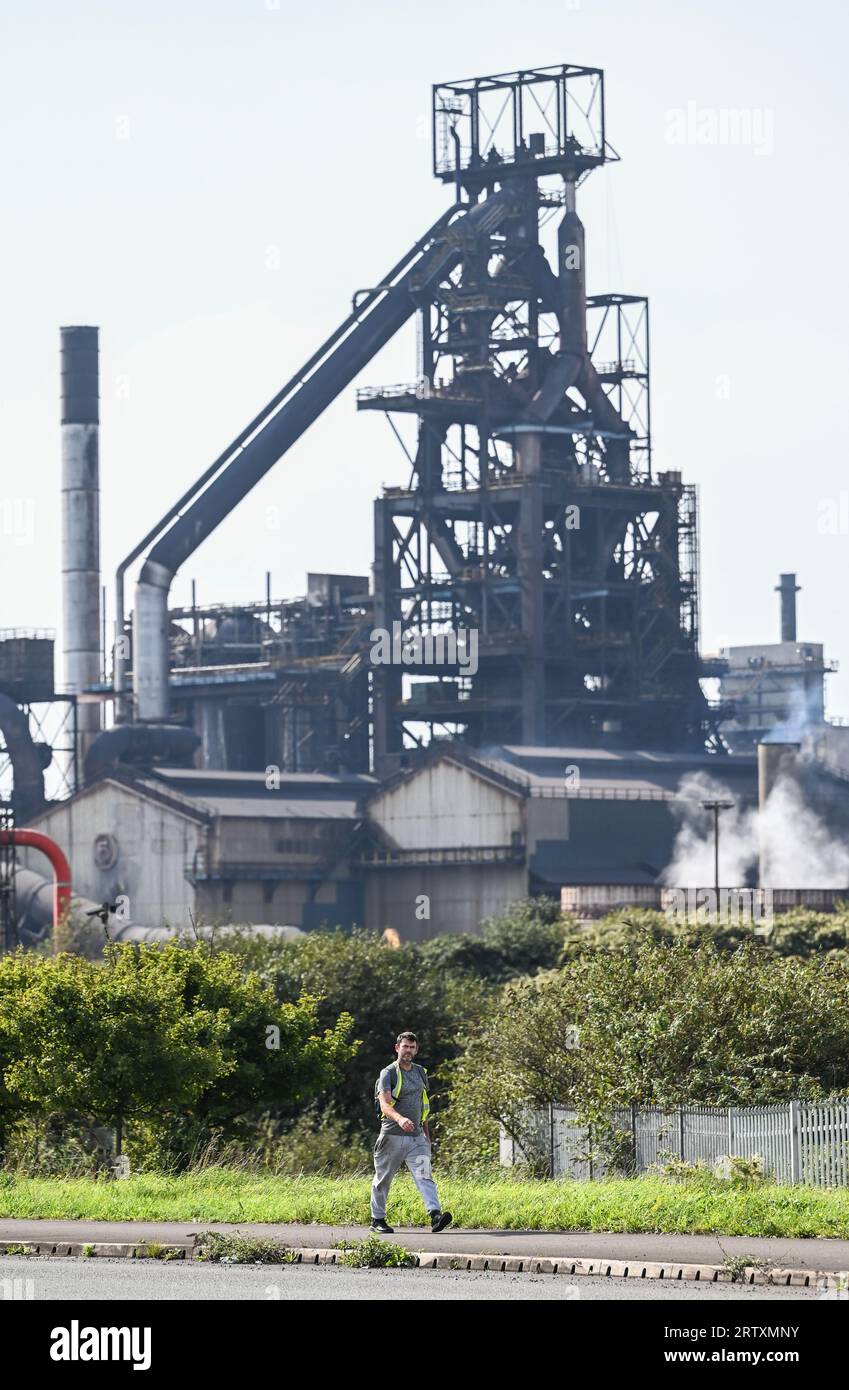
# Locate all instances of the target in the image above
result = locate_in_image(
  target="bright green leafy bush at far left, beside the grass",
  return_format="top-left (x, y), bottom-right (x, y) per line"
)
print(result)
top-left (0, 942), bottom-right (356, 1163)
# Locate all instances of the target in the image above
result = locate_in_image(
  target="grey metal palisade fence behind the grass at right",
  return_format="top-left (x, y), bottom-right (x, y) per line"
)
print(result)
top-left (500, 1098), bottom-right (849, 1187)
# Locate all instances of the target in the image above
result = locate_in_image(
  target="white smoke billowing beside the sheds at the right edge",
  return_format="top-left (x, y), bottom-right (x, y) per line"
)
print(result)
top-left (661, 773), bottom-right (849, 888)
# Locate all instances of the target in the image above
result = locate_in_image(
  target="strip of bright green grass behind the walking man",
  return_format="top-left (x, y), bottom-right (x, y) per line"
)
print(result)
top-left (0, 1168), bottom-right (849, 1238)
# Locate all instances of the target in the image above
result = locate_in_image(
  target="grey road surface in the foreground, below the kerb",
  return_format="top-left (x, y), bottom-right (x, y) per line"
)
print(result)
top-left (0, 1255), bottom-right (825, 1295)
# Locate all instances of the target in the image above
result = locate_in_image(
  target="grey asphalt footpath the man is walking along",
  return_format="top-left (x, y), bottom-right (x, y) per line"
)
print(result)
top-left (0, 1219), bottom-right (849, 1270)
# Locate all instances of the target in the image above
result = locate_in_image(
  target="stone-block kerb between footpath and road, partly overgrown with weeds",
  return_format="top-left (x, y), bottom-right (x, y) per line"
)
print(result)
top-left (0, 1240), bottom-right (848, 1290)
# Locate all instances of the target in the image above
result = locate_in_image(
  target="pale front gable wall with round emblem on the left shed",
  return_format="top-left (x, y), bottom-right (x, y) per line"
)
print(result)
top-left (22, 781), bottom-right (206, 927)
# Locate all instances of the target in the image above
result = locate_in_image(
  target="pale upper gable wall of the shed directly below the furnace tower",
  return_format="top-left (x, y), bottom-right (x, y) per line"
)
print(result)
top-left (368, 762), bottom-right (522, 849)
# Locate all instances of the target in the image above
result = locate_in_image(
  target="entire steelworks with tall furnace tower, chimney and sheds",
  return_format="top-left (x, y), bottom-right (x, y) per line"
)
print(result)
top-left (0, 64), bottom-right (849, 941)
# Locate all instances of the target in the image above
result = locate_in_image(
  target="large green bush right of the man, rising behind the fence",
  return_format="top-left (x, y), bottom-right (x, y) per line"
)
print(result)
top-left (446, 933), bottom-right (849, 1158)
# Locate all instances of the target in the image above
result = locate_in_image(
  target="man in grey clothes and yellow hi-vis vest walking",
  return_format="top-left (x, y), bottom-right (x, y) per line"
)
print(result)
top-left (371, 1033), bottom-right (453, 1236)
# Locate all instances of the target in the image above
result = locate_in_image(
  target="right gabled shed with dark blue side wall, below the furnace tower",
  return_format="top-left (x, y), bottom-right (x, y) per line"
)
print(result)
top-left (361, 745), bottom-right (757, 940)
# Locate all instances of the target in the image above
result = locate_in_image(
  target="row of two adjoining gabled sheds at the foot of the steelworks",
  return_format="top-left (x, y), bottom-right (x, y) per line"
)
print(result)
top-left (13, 744), bottom-right (757, 941)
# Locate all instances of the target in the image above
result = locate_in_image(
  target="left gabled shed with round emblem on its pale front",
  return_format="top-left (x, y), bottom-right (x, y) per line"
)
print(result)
top-left (24, 769), bottom-right (374, 929)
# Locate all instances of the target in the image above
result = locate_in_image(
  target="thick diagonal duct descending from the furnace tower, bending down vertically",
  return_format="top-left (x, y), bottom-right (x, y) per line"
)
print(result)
top-left (133, 190), bottom-right (513, 723)
